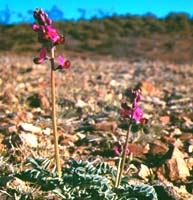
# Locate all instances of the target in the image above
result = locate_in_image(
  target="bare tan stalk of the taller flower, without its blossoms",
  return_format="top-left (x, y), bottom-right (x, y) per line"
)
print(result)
top-left (50, 47), bottom-right (61, 176)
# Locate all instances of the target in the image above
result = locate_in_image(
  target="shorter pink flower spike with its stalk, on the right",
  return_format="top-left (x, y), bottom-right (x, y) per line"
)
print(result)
top-left (115, 89), bottom-right (146, 187)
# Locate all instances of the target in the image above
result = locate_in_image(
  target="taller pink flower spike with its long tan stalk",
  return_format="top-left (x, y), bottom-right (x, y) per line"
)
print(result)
top-left (32, 9), bottom-right (70, 176)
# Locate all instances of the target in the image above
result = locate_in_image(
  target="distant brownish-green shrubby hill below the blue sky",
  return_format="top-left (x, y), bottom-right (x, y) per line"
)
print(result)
top-left (0, 13), bottom-right (193, 62)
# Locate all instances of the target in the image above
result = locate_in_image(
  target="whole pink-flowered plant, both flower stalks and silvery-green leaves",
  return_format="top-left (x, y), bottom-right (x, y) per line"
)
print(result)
top-left (15, 9), bottom-right (158, 200)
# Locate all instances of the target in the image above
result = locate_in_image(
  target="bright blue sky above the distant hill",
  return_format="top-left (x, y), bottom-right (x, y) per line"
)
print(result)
top-left (0, 0), bottom-right (193, 23)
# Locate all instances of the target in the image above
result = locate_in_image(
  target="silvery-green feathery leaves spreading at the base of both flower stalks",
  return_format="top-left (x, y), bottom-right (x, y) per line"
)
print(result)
top-left (15, 158), bottom-right (157, 200)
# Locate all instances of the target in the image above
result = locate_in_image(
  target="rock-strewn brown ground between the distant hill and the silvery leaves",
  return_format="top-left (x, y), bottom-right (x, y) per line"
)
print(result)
top-left (0, 55), bottom-right (193, 200)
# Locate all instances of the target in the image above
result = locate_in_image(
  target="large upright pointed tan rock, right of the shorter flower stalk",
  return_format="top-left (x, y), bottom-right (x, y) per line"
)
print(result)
top-left (166, 147), bottom-right (190, 181)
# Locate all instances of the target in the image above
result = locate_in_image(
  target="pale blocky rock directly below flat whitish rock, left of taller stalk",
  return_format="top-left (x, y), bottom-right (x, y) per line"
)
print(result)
top-left (20, 133), bottom-right (38, 148)
